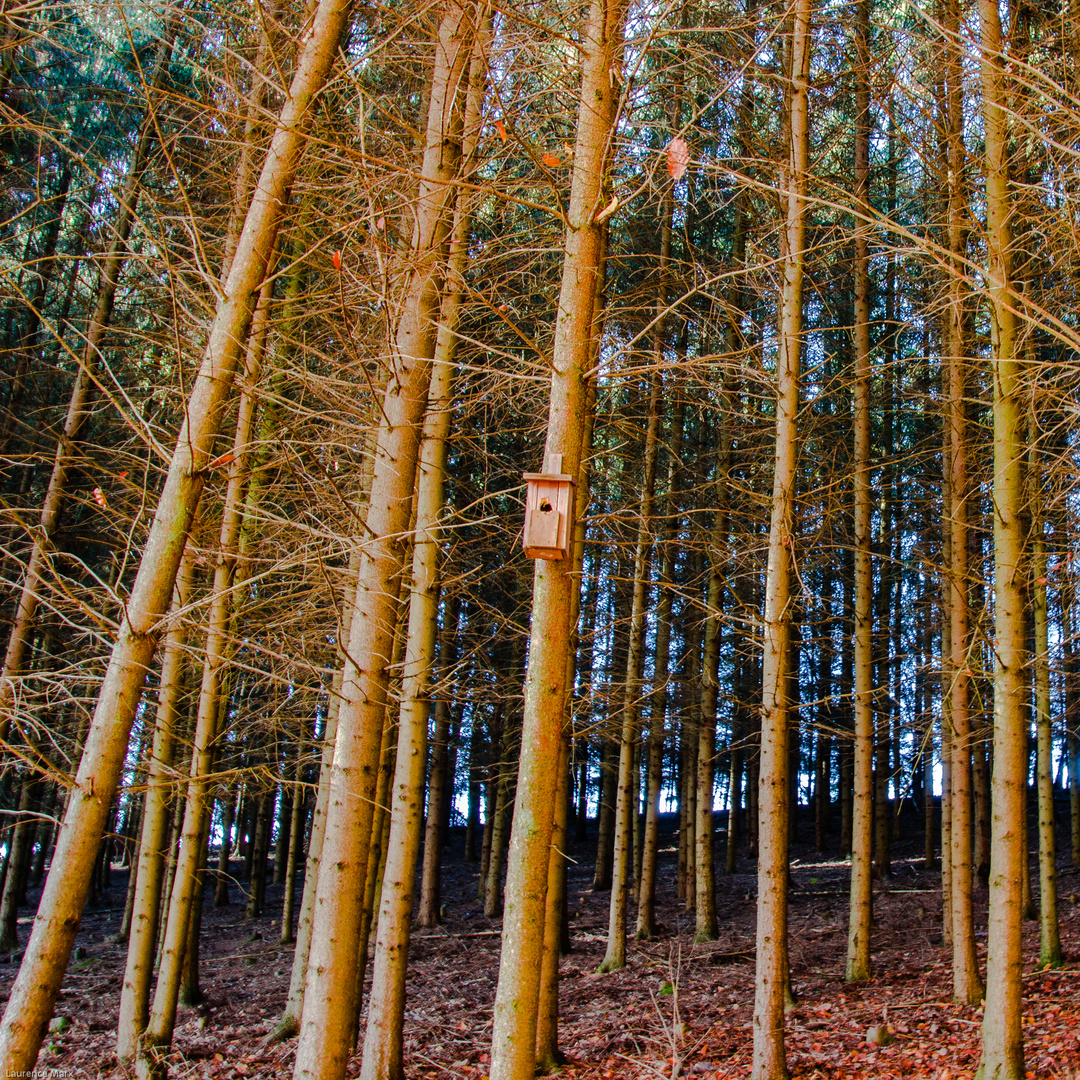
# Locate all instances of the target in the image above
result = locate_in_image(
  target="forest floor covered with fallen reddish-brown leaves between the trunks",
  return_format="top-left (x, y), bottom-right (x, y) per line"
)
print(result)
top-left (6, 816), bottom-right (1080, 1080)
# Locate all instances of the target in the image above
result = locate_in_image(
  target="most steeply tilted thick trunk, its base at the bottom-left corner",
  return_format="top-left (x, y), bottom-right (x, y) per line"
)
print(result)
top-left (0, 0), bottom-right (349, 1072)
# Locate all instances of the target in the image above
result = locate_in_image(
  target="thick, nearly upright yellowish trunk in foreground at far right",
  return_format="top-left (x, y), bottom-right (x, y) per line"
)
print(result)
top-left (976, 0), bottom-right (1027, 1080)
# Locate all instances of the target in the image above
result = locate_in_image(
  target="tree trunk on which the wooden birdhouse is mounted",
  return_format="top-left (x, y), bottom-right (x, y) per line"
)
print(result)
top-left (489, 0), bottom-right (625, 1080)
